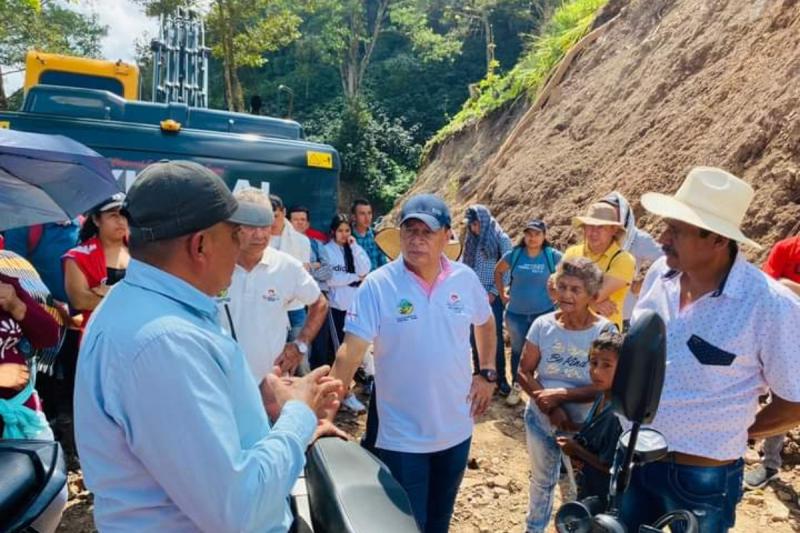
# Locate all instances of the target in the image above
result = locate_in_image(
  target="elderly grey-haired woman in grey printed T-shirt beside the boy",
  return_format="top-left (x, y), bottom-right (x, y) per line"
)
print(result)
top-left (518, 257), bottom-right (616, 533)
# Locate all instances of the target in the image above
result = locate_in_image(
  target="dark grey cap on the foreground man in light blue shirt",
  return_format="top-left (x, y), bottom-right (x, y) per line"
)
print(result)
top-left (122, 161), bottom-right (238, 242)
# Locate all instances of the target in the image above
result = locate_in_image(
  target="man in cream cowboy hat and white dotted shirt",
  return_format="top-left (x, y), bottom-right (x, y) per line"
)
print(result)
top-left (622, 167), bottom-right (800, 533)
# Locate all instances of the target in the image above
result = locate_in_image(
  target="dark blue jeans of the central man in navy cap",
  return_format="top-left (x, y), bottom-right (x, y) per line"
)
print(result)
top-left (378, 438), bottom-right (472, 533)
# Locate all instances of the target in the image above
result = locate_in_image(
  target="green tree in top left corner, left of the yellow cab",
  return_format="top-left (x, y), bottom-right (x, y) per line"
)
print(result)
top-left (0, 0), bottom-right (107, 109)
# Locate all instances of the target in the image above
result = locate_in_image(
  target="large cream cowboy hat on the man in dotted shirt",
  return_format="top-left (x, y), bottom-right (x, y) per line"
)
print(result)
top-left (642, 167), bottom-right (761, 250)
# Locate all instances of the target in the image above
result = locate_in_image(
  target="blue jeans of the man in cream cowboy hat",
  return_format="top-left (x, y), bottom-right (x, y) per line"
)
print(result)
top-left (621, 459), bottom-right (744, 533)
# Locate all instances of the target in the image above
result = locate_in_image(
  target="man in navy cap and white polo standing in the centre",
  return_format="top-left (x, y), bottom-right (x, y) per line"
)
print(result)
top-left (331, 194), bottom-right (497, 533)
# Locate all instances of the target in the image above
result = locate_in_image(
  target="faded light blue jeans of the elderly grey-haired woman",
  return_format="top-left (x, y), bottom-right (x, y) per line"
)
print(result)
top-left (525, 402), bottom-right (566, 533)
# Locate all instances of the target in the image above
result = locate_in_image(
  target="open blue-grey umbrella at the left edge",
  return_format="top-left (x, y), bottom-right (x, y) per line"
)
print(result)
top-left (0, 129), bottom-right (120, 230)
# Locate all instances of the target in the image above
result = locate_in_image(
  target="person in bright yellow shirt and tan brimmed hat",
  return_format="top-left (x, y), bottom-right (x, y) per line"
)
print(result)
top-left (564, 202), bottom-right (636, 331)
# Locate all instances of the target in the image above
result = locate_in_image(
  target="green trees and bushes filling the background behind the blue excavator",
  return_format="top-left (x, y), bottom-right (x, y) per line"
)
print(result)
top-left (0, 0), bottom-right (607, 211)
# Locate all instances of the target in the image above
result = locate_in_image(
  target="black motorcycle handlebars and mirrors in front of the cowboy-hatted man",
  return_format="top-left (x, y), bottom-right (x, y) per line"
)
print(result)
top-left (556, 312), bottom-right (698, 533)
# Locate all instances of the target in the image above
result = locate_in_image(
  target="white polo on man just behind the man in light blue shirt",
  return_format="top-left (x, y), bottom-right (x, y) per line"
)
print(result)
top-left (217, 248), bottom-right (320, 383)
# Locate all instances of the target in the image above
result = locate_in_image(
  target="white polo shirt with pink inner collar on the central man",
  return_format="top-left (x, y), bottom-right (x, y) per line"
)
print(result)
top-left (345, 258), bottom-right (492, 453)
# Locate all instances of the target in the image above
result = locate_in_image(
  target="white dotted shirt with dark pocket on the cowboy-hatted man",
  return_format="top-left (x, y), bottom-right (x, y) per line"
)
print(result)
top-left (633, 253), bottom-right (800, 460)
